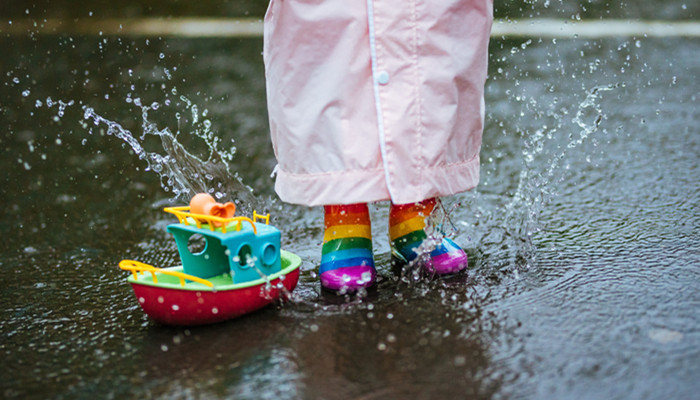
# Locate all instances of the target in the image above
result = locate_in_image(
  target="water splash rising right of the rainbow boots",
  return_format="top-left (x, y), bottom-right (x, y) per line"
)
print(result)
top-left (401, 84), bottom-right (623, 283)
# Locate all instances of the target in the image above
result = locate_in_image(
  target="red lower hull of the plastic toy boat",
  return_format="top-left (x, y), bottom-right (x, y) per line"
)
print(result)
top-left (131, 268), bottom-right (299, 326)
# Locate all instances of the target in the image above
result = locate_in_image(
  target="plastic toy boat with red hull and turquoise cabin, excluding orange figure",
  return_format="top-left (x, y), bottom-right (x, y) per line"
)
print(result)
top-left (119, 202), bottom-right (301, 325)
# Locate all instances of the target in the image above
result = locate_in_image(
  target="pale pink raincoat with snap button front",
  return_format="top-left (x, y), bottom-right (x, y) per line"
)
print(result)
top-left (263, 0), bottom-right (493, 206)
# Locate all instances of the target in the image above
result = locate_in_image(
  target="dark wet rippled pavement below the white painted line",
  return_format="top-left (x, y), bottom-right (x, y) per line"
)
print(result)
top-left (0, 5), bottom-right (700, 399)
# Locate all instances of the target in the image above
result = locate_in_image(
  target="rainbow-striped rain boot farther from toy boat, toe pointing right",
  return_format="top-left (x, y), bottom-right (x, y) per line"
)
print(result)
top-left (389, 199), bottom-right (467, 275)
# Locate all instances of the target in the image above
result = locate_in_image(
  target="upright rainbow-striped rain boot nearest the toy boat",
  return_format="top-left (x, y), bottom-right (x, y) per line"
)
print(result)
top-left (320, 204), bottom-right (376, 290)
